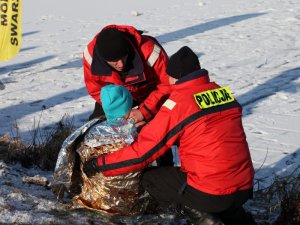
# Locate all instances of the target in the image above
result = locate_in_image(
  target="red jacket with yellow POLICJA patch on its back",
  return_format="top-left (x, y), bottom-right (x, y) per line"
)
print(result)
top-left (98, 69), bottom-right (254, 195)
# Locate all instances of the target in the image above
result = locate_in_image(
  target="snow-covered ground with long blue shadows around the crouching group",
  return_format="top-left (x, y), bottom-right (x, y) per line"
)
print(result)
top-left (0, 0), bottom-right (300, 224)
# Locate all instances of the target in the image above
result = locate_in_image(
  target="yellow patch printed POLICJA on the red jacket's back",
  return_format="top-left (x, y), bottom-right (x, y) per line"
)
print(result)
top-left (194, 86), bottom-right (234, 109)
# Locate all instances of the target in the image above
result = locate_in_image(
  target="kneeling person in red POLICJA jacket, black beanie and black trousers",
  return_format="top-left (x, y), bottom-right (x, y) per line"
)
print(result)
top-left (84, 47), bottom-right (255, 225)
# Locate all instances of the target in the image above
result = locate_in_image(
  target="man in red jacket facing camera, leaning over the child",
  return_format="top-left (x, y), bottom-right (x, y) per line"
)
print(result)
top-left (83, 25), bottom-right (169, 122)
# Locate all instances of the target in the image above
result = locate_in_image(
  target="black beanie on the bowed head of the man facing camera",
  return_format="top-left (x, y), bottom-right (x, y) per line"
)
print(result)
top-left (95, 28), bottom-right (129, 61)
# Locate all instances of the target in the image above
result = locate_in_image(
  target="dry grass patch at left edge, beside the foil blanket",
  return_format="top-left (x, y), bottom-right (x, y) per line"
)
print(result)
top-left (0, 116), bottom-right (74, 170)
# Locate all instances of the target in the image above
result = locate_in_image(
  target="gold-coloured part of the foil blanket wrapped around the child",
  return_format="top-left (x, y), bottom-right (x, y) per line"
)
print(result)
top-left (73, 142), bottom-right (148, 215)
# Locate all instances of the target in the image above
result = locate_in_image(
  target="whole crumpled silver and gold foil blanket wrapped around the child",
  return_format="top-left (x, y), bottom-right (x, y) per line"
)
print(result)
top-left (52, 119), bottom-right (149, 215)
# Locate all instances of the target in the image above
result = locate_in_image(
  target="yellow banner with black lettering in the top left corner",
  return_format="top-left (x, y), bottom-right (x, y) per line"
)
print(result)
top-left (0, 0), bottom-right (22, 61)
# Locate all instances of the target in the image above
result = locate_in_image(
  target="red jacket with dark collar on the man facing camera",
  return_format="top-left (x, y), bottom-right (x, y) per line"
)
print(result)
top-left (83, 25), bottom-right (169, 120)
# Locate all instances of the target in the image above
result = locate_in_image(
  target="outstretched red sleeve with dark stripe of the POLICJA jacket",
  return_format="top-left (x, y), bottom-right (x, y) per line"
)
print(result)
top-left (98, 102), bottom-right (182, 176)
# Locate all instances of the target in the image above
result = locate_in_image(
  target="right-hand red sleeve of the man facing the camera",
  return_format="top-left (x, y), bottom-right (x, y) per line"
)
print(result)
top-left (139, 40), bottom-right (170, 121)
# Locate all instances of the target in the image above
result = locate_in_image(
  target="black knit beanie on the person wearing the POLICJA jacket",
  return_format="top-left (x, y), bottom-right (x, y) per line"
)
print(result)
top-left (167, 46), bottom-right (201, 79)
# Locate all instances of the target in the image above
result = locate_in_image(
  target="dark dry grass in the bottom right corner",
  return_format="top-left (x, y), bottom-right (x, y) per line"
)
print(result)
top-left (249, 167), bottom-right (300, 225)
